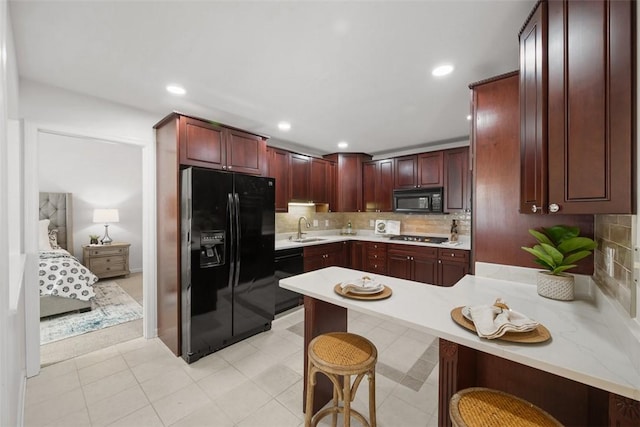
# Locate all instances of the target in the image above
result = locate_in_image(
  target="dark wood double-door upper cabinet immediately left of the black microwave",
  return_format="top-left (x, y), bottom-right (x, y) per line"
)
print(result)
top-left (362, 159), bottom-right (394, 212)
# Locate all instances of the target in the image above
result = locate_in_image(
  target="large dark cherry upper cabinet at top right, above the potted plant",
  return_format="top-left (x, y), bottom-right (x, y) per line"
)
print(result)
top-left (520, 0), bottom-right (636, 214)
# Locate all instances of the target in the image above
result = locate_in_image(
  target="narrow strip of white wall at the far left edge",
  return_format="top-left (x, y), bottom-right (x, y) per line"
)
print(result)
top-left (0, 1), bottom-right (26, 426)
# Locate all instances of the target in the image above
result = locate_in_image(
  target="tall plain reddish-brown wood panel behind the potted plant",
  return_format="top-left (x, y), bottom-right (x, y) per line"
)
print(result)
top-left (470, 72), bottom-right (594, 275)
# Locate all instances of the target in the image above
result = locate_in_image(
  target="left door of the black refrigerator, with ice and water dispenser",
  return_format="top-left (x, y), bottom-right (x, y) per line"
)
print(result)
top-left (182, 168), bottom-right (233, 362)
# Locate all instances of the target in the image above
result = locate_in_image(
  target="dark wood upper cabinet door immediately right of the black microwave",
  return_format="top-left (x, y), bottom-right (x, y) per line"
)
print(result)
top-left (444, 147), bottom-right (471, 212)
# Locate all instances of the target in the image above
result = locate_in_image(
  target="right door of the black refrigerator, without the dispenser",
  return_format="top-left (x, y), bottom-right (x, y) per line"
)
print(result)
top-left (233, 174), bottom-right (276, 336)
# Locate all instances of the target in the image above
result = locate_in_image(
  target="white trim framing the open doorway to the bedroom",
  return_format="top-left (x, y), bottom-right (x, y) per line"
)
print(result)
top-left (24, 121), bottom-right (157, 377)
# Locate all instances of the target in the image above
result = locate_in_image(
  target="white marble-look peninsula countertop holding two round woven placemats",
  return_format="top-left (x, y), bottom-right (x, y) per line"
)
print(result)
top-left (280, 267), bottom-right (640, 400)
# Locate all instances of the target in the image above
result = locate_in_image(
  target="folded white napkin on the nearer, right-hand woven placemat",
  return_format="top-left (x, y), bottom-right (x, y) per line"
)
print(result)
top-left (469, 305), bottom-right (539, 339)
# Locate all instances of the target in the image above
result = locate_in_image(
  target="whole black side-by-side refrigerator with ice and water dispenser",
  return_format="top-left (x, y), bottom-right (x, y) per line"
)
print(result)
top-left (180, 167), bottom-right (277, 363)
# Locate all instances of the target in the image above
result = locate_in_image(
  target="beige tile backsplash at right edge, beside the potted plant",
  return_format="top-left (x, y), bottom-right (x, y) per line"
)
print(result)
top-left (593, 215), bottom-right (637, 317)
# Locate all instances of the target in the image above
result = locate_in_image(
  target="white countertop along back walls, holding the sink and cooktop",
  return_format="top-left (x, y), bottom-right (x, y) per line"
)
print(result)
top-left (275, 230), bottom-right (471, 251)
